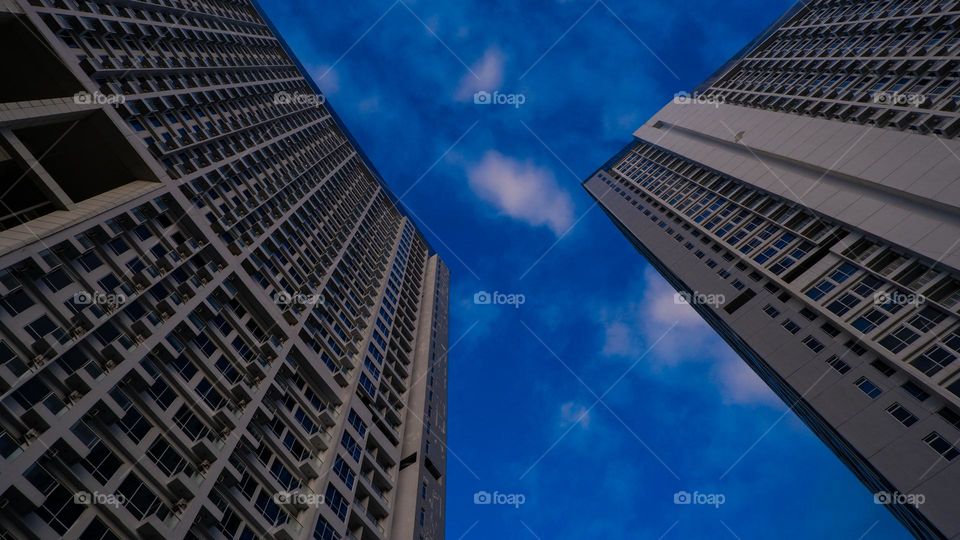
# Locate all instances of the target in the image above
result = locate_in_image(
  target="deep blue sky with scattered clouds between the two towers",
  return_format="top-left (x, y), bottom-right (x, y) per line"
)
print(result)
top-left (263, 0), bottom-right (907, 539)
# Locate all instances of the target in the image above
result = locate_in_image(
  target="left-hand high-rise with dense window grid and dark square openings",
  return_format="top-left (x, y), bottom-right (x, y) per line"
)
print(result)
top-left (0, 0), bottom-right (449, 540)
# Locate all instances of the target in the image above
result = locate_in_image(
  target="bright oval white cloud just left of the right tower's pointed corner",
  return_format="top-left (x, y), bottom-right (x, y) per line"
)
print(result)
top-left (467, 150), bottom-right (573, 236)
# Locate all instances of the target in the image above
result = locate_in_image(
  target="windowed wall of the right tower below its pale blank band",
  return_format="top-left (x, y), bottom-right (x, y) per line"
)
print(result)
top-left (585, 134), bottom-right (960, 537)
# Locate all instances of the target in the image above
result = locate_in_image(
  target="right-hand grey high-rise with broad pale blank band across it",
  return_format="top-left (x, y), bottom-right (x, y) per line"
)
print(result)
top-left (584, 0), bottom-right (960, 538)
